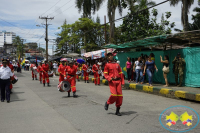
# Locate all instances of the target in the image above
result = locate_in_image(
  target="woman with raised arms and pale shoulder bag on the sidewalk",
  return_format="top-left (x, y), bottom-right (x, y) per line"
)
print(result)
top-left (160, 55), bottom-right (169, 87)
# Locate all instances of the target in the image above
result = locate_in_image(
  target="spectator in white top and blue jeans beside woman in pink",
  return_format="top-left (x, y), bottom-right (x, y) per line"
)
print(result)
top-left (133, 57), bottom-right (144, 84)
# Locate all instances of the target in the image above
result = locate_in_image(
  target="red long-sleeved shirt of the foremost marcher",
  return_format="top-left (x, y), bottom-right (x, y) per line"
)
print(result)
top-left (104, 62), bottom-right (124, 84)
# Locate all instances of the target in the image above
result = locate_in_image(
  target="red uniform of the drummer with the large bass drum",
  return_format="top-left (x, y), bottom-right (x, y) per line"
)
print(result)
top-left (65, 65), bottom-right (77, 92)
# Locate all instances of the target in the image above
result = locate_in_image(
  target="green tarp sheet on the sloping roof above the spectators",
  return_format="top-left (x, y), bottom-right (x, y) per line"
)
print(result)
top-left (104, 35), bottom-right (167, 49)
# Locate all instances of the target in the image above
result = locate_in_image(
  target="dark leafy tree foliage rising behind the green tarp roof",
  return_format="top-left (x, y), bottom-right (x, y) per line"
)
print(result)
top-left (121, 5), bottom-right (175, 42)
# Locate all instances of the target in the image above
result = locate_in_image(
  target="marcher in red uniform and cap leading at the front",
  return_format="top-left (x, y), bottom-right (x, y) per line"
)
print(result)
top-left (104, 53), bottom-right (124, 116)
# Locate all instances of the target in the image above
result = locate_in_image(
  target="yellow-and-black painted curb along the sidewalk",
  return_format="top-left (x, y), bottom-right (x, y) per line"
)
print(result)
top-left (79, 76), bottom-right (200, 102)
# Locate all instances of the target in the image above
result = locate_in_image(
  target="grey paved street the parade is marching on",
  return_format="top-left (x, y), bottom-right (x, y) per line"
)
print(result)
top-left (0, 72), bottom-right (200, 133)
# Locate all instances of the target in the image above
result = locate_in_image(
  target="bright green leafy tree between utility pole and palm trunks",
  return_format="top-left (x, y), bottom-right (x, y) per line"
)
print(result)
top-left (55, 18), bottom-right (108, 55)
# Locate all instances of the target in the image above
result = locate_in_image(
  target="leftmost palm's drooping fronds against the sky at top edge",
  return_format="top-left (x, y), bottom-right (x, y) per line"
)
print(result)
top-left (75, 0), bottom-right (104, 18)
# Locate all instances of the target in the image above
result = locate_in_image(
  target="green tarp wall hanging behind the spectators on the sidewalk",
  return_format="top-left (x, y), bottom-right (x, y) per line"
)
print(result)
top-left (116, 47), bottom-right (200, 87)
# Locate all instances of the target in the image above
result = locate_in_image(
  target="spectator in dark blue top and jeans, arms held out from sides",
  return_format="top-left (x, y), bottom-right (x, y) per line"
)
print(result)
top-left (144, 56), bottom-right (158, 86)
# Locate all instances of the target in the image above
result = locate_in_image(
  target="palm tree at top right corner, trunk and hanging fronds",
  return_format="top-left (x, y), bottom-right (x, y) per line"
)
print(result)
top-left (170, 0), bottom-right (194, 31)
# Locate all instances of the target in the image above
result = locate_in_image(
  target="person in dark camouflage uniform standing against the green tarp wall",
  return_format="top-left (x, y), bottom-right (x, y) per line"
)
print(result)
top-left (172, 53), bottom-right (185, 87)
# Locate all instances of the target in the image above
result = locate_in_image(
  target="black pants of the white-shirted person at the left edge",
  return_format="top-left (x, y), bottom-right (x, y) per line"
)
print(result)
top-left (0, 79), bottom-right (10, 101)
